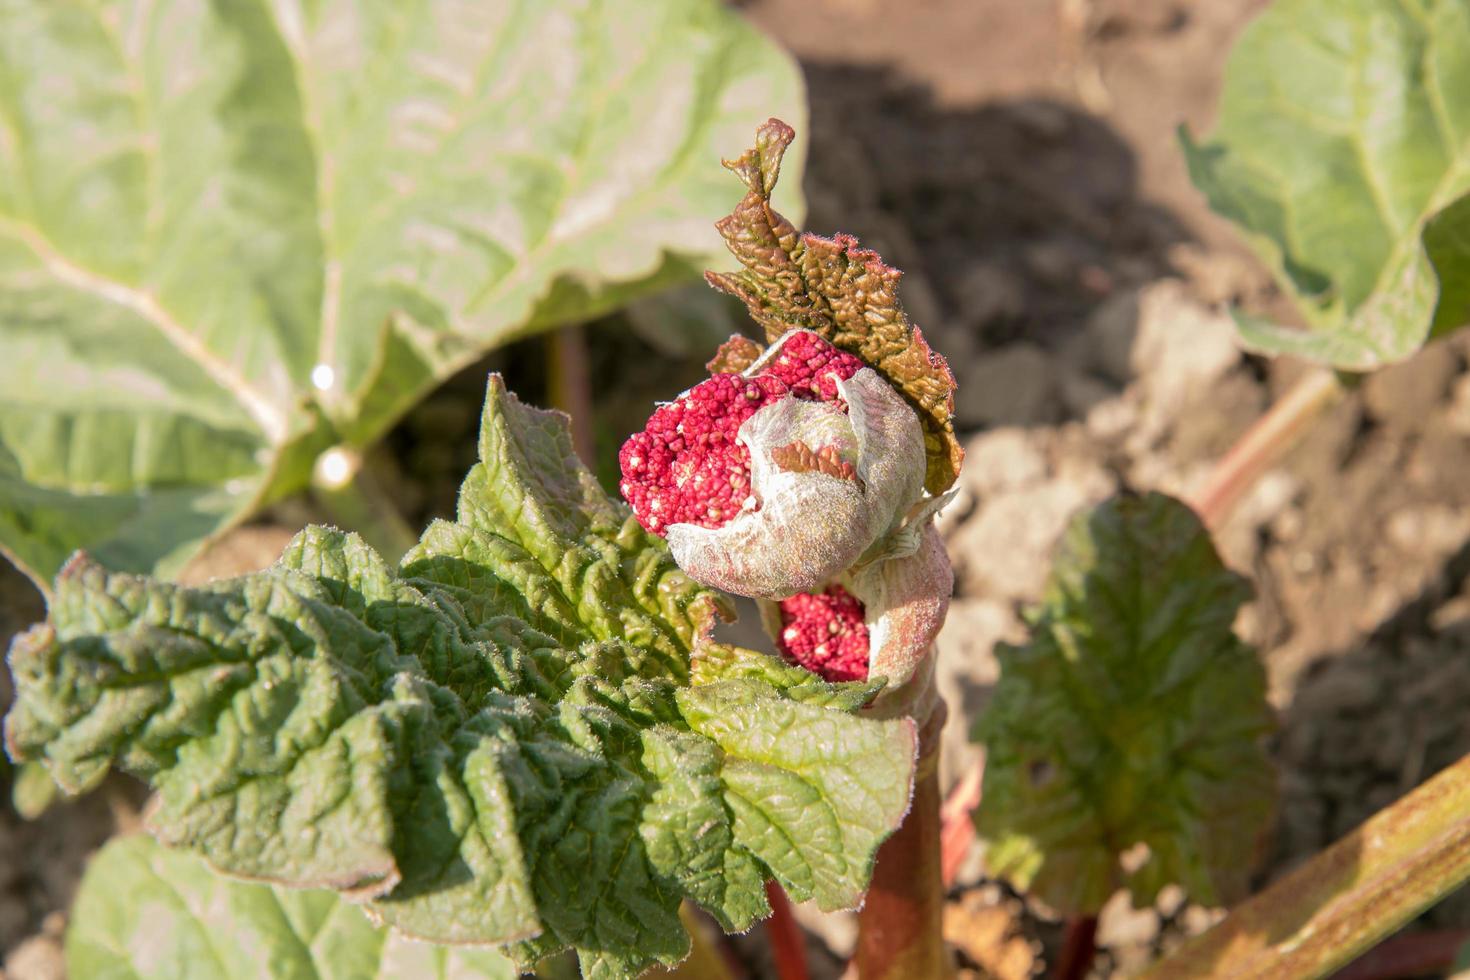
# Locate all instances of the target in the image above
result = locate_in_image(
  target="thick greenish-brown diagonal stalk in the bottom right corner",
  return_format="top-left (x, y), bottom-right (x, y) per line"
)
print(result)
top-left (1145, 755), bottom-right (1470, 980)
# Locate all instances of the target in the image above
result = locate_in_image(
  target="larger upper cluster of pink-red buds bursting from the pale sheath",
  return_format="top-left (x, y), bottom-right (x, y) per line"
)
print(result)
top-left (617, 334), bottom-right (863, 535)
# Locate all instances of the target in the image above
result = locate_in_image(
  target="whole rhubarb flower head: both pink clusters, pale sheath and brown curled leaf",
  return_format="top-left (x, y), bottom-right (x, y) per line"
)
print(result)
top-left (619, 119), bottom-right (964, 721)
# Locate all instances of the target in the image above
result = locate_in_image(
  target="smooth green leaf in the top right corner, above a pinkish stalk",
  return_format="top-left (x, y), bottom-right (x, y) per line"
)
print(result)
top-left (1185, 0), bottom-right (1470, 370)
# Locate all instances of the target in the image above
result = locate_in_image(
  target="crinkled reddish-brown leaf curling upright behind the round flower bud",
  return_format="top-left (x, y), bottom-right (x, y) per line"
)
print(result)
top-left (704, 119), bottom-right (964, 494)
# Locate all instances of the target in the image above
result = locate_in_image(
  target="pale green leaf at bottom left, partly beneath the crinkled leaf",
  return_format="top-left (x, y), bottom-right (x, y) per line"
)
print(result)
top-left (66, 836), bottom-right (519, 980)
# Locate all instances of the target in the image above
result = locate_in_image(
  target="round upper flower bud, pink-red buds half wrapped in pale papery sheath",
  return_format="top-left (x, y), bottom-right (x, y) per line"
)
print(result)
top-left (619, 331), bottom-right (925, 598)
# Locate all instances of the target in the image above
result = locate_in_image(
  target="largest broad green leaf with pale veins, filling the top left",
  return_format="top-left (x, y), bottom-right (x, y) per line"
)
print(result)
top-left (0, 0), bottom-right (803, 579)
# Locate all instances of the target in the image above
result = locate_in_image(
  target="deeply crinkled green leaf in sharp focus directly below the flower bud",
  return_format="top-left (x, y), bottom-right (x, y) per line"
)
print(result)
top-left (6, 378), bottom-right (916, 977)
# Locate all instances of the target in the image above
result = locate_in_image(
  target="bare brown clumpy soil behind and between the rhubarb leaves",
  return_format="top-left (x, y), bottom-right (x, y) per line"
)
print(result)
top-left (0, 0), bottom-right (1470, 980)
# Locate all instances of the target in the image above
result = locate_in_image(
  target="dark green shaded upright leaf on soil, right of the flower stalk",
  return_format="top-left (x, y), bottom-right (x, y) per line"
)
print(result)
top-left (976, 494), bottom-right (1274, 914)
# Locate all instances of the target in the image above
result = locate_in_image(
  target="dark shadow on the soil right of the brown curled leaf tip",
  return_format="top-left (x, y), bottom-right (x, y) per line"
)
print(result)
top-left (804, 63), bottom-right (1188, 350)
